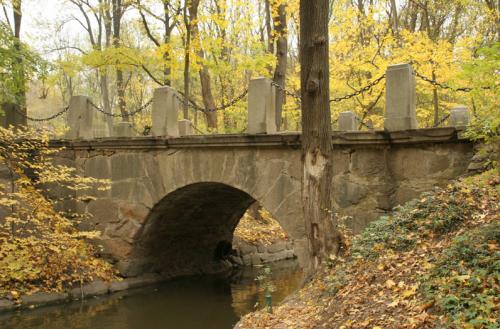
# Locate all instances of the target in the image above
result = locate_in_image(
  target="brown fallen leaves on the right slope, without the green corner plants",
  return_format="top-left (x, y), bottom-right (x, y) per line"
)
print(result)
top-left (238, 169), bottom-right (500, 329)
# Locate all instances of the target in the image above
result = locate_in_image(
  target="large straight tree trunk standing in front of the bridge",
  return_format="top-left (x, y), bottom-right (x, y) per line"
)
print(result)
top-left (300, 0), bottom-right (340, 269)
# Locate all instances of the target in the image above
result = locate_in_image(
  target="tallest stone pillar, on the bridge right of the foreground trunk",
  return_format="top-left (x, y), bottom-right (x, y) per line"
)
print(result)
top-left (384, 64), bottom-right (417, 131)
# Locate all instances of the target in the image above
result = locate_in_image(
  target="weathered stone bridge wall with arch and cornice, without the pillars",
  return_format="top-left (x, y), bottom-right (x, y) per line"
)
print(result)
top-left (53, 128), bottom-right (472, 276)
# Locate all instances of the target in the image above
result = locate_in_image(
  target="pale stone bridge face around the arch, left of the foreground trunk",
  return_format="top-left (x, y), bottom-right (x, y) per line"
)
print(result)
top-left (79, 147), bottom-right (308, 276)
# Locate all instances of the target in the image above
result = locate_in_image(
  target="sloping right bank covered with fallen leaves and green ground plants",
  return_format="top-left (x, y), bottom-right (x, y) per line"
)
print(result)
top-left (236, 170), bottom-right (500, 329)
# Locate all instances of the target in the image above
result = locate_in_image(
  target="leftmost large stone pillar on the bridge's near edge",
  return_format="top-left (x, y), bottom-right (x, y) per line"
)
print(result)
top-left (66, 96), bottom-right (95, 139)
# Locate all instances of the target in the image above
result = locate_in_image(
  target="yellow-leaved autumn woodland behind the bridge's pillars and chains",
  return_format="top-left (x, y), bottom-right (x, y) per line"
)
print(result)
top-left (0, 0), bottom-right (500, 133)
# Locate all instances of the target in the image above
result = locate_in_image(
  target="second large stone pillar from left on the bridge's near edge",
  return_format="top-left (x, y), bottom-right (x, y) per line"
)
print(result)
top-left (152, 87), bottom-right (181, 137)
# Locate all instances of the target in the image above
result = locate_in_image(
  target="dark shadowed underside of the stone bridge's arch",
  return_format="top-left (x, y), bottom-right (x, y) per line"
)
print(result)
top-left (123, 182), bottom-right (302, 277)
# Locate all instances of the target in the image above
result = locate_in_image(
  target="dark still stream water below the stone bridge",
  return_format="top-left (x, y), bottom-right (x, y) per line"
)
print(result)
top-left (0, 261), bottom-right (302, 329)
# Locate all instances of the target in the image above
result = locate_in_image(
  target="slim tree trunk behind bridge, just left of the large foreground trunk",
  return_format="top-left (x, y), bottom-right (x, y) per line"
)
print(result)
top-left (273, 4), bottom-right (288, 130)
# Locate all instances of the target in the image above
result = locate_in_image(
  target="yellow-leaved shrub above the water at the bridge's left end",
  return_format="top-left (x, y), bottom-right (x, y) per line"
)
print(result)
top-left (0, 128), bottom-right (114, 298)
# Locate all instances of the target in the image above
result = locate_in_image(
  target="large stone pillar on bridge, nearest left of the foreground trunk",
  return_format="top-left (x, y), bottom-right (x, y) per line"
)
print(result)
top-left (247, 78), bottom-right (277, 134)
